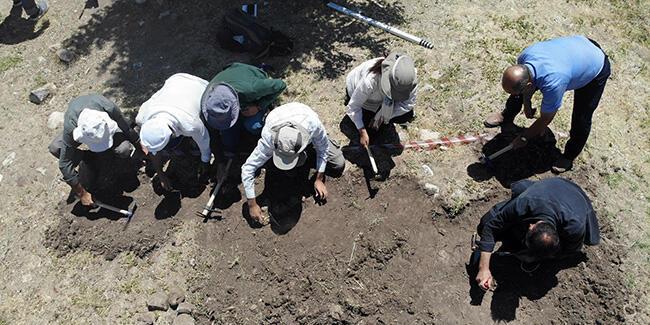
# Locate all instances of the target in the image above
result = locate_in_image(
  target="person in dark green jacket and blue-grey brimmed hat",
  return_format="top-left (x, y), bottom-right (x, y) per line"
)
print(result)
top-left (201, 63), bottom-right (287, 154)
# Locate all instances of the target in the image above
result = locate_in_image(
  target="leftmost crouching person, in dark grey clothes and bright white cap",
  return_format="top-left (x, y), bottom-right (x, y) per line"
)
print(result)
top-left (48, 94), bottom-right (140, 206)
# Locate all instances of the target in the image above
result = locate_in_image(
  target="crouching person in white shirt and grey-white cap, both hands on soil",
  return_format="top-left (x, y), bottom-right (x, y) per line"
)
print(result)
top-left (241, 103), bottom-right (345, 222)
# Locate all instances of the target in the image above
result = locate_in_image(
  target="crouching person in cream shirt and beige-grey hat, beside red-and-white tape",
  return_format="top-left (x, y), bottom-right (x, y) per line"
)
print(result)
top-left (345, 50), bottom-right (417, 147)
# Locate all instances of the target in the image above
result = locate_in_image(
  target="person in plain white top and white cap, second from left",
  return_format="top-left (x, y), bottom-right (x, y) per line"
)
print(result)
top-left (135, 73), bottom-right (212, 190)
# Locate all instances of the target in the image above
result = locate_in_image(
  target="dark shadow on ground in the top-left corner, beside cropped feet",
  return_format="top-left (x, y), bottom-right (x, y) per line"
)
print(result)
top-left (0, 6), bottom-right (50, 45)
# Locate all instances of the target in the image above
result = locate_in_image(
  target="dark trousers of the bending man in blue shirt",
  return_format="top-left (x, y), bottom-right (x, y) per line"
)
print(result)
top-left (503, 41), bottom-right (611, 160)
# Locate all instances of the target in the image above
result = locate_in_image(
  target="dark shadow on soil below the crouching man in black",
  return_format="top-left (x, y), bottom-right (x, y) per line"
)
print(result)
top-left (466, 252), bottom-right (587, 322)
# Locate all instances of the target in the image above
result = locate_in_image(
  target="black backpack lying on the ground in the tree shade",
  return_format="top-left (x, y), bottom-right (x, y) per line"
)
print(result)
top-left (217, 9), bottom-right (293, 58)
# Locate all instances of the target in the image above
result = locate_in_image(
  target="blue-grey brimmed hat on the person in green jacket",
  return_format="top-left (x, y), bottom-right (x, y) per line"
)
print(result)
top-left (201, 82), bottom-right (241, 130)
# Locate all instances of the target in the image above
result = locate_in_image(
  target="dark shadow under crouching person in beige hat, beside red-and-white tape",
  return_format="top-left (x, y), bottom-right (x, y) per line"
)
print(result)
top-left (339, 115), bottom-right (404, 199)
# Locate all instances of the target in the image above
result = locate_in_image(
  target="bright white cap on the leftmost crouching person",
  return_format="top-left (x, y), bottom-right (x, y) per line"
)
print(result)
top-left (72, 108), bottom-right (118, 152)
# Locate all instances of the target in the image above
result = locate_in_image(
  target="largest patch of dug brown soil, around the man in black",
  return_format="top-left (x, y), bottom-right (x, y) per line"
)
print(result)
top-left (187, 175), bottom-right (631, 324)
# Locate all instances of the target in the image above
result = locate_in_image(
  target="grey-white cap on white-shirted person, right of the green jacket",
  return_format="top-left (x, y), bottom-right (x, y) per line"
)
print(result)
top-left (271, 121), bottom-right (310, 170)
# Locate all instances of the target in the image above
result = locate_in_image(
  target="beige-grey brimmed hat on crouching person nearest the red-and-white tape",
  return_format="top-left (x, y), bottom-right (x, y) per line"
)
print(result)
top-left (381, 50), bottom-right (418, 102)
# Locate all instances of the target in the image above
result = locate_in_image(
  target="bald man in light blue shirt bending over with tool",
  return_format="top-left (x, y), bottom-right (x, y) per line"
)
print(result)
top-left (484, 36), bottom-right (610, 173)
